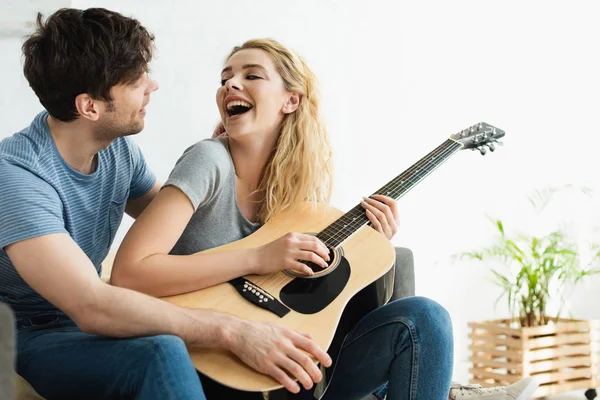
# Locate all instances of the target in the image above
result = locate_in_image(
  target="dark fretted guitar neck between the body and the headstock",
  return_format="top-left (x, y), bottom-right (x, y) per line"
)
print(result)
top-left (317, 139), bottom-right (463, 248)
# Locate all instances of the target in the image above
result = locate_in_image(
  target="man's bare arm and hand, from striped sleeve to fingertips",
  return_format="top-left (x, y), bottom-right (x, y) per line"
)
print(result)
top-left (5, 233), bottom-right (331, 392)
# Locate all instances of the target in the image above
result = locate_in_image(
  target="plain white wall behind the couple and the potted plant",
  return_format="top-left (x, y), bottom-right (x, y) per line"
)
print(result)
top-left (0, 0), bottom-right (600, 379)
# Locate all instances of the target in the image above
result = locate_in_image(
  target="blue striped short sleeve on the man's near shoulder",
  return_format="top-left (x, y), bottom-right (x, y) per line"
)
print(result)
top-left (0, 161), bottom-right (67, 249)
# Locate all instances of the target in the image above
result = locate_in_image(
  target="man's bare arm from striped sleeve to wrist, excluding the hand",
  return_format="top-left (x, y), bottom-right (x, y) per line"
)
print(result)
top-left (6, 233), bottom-right (231, 347)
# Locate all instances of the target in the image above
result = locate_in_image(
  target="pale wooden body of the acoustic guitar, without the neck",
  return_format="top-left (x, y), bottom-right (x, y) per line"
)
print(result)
top-left (164, 202), bottom-right (395, 392)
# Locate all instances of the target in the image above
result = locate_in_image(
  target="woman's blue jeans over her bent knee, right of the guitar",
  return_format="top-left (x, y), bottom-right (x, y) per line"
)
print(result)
top-left (323, 297), bottom-right (454, 400)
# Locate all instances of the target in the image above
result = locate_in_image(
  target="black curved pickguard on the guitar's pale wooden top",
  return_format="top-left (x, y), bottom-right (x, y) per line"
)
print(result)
top-left (279, 256), bottom-right (350, 314)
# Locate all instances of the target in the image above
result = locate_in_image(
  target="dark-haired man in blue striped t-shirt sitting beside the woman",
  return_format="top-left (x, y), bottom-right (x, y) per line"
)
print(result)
top-left (0, 9), bottom-right (540, 399)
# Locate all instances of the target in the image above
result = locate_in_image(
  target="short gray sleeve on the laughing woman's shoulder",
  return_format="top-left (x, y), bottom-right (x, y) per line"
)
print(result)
top-left (164, 139), bottom-right (233, 210)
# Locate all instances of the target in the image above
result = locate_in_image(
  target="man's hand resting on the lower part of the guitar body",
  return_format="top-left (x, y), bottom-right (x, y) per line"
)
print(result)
top-left (230, 320), bottom-right (332, 393)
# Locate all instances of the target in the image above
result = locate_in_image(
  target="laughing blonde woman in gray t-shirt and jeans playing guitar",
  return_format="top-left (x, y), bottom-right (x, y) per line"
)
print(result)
top-left (112, 40), bottom-right (536, 400)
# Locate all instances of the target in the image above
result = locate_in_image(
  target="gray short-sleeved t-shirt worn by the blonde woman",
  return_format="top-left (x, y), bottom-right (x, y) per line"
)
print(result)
top-left (164, 137), bottom-right (261, 255)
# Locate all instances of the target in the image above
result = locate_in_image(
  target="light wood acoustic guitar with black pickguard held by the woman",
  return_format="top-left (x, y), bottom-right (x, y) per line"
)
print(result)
top-left (164, 122), bottom-right (505, 398)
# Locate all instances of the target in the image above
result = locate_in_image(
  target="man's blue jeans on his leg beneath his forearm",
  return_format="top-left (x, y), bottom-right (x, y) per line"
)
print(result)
top-left (17, 320), bottom-right (206, 400)
